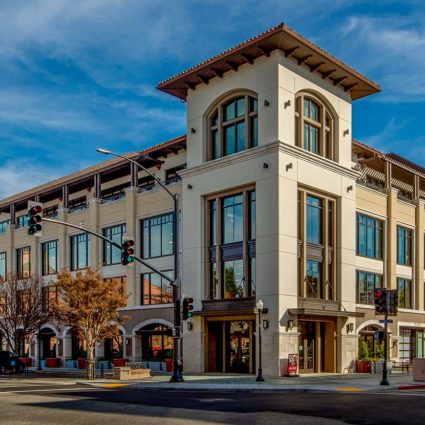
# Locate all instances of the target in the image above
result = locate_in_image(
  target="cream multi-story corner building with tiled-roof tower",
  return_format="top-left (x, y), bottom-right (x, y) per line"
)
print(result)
top-left (0, 24), bottom-right (425, 375)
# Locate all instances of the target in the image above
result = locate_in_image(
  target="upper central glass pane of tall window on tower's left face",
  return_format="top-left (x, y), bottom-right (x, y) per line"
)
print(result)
top-left (222, 194), bottom-right (244, 244)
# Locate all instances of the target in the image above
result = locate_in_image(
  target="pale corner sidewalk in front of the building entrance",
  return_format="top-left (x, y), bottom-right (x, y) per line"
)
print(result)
top-left (78, 373), bottom-right (425, 392)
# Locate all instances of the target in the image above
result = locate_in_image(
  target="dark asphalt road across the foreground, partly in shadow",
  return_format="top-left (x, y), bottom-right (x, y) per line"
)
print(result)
top-left (0, 379), bottom-right (425, 425)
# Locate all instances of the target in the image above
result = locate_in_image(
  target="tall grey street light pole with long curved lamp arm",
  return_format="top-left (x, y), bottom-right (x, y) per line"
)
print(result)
top-left (97, 148), bottom-right (184, 382)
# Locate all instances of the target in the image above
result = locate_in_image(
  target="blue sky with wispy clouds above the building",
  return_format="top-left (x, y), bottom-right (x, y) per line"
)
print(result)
top-left (0, 0), bottom-right (425, 198)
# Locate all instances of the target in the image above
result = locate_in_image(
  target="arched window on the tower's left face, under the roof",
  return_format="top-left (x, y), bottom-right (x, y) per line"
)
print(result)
top-left (208, 95), bottom-right (258, 159)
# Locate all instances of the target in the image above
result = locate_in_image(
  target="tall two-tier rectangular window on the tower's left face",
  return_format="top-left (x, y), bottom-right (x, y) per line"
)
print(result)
top-left (208, 190), bottom-right (256, 299)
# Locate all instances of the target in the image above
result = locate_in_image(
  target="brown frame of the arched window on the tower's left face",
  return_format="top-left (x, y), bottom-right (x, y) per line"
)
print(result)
top-left (207, 91), bottom-right (259, 161)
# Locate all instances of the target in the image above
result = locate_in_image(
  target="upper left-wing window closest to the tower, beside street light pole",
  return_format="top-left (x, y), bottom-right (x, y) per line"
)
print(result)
top-left (142, 214), bottom-right (174, 258)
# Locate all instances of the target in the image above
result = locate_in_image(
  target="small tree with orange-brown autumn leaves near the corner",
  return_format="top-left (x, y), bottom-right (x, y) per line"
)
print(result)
top-left (54, 268), bottom-right (127, 380)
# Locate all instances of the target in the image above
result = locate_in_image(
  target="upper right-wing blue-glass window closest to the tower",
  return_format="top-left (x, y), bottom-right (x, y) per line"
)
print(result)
top-left (357, 214), bottom-right (384, 260)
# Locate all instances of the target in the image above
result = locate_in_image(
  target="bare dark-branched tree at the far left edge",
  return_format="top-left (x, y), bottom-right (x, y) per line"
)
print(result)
top-left (0, 273), bottom-right (51, 356)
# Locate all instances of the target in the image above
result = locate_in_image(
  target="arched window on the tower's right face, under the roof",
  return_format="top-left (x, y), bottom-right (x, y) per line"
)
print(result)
top-left (295, 93), bottom-right (336, 160)
